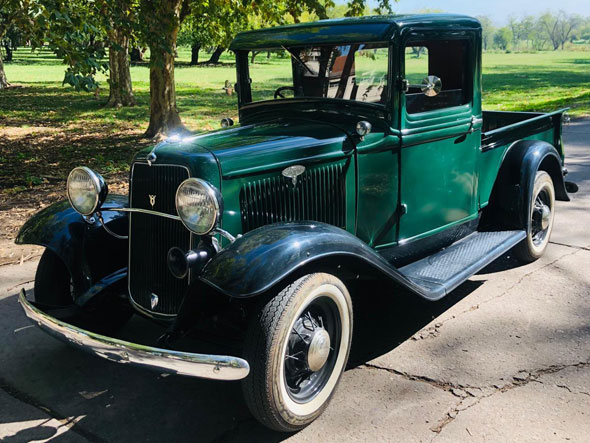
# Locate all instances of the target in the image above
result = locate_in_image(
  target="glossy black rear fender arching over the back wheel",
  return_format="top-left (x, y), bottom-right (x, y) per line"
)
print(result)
top-left (482, 140), bottom-right (570, 229)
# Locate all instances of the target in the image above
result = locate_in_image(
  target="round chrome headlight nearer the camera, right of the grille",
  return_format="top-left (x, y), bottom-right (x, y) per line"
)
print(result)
top-left (176, 178), bottom-right (223, 235)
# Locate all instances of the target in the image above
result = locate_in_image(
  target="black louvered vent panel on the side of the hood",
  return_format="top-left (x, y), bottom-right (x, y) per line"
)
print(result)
top-left (240, 162), bottom-right (346, 233)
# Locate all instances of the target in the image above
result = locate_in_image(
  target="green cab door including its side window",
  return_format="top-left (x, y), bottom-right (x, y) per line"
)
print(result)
top-left (399, 32), bottom-right (480, 243)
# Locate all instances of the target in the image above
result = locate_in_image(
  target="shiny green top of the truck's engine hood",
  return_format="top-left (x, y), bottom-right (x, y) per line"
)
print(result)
top-left (136, 120), bottom-right (352, 182)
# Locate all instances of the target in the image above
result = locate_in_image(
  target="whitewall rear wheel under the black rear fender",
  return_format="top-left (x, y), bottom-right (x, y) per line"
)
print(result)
top-left (514, 171), bottom-right (555, 263)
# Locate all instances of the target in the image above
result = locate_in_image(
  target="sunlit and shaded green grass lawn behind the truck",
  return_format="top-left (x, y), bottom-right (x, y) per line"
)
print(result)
top-left (0, 48), bottom-right (590, 197)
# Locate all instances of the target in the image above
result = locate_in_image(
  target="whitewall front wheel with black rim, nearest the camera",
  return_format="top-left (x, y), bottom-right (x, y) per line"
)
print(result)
top-left (242, 273), bottom-right (352, 432)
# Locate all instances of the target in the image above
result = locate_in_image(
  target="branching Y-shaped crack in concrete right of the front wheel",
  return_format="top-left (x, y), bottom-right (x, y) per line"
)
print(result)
top-left (363, 360), bottom-right (590, 442)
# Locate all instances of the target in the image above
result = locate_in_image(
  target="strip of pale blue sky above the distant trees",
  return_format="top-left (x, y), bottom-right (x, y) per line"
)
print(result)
top-left (370, 0), bottom-right (590, 25)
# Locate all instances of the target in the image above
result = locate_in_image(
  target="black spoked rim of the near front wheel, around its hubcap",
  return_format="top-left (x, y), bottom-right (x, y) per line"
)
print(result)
top-left (284, 296), bottom-right (342, 403)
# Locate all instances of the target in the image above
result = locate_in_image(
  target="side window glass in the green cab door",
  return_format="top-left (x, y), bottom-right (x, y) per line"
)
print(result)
top-left (405, 40), bottom-right (472, 114)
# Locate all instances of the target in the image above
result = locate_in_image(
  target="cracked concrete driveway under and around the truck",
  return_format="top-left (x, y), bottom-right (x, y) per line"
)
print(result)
top-left (0, 121), bottom-right (590, 442)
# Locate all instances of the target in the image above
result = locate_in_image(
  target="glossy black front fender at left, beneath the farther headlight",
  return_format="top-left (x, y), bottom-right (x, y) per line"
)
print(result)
top-left (16, 195), bottom-right (129, 295)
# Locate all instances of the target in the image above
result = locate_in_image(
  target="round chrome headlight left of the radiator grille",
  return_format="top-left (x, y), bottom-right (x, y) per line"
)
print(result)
top-left (67, 166), bottom-right (108, 215)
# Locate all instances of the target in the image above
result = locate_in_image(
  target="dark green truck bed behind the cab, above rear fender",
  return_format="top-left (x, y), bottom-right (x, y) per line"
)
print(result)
top-left (481, 109), bottom-right (567, 154)
